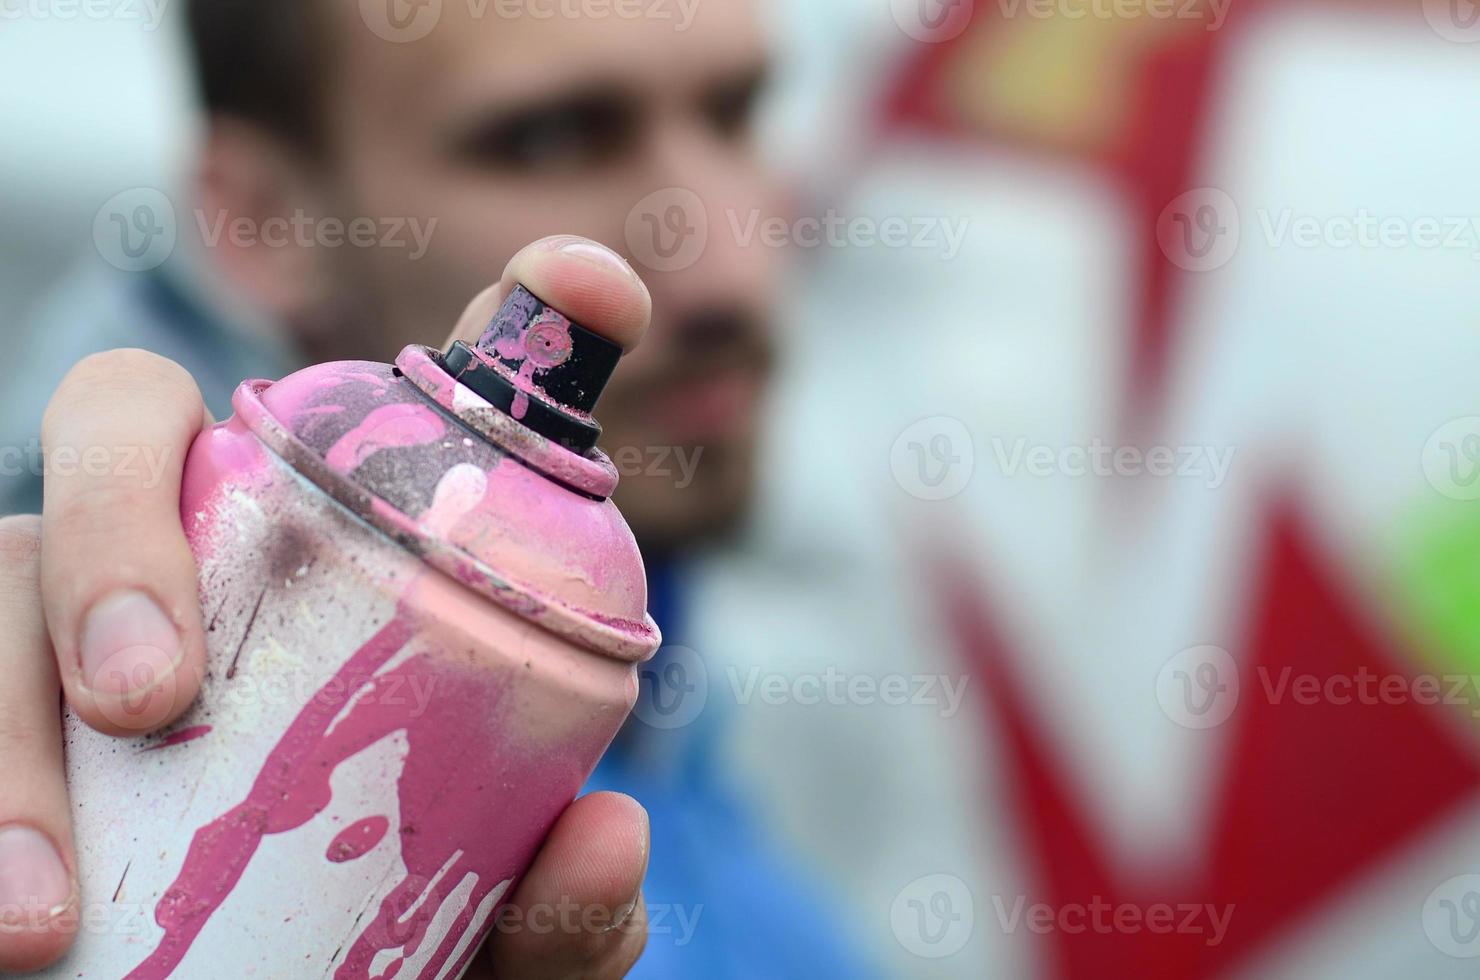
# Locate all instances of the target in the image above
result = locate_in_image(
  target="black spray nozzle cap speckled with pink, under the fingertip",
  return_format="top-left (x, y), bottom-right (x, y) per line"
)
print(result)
top-left (445, 286), bottom-right (622, 453)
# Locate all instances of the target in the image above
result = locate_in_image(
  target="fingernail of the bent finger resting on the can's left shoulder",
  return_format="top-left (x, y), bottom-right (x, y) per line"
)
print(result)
top-left (81, 591), bottom-right (184, 694)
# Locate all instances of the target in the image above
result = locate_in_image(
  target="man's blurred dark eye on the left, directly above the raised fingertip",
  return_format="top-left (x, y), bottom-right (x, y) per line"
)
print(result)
top-left (449, 99), bottom-right (638, 173)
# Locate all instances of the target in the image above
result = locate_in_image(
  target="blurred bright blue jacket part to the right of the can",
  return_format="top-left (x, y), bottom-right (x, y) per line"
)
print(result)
top-left (589, 564), bottom-right (873, 980)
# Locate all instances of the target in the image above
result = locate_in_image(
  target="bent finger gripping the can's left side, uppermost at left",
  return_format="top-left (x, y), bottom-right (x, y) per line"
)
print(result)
top-left (41, 351), bottom-right (209, 734)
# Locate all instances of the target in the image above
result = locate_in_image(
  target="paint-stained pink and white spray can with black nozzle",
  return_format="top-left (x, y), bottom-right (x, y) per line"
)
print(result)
top-left (50, 287), bottom-right (659, 980)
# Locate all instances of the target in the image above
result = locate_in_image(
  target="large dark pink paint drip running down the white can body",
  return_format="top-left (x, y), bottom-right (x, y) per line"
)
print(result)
top-left (127, 613), bottom-right (602, 980)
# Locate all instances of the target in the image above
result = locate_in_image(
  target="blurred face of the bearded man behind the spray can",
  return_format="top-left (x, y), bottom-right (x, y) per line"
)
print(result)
top-left (285, 0), bottom-right (774, 549)
